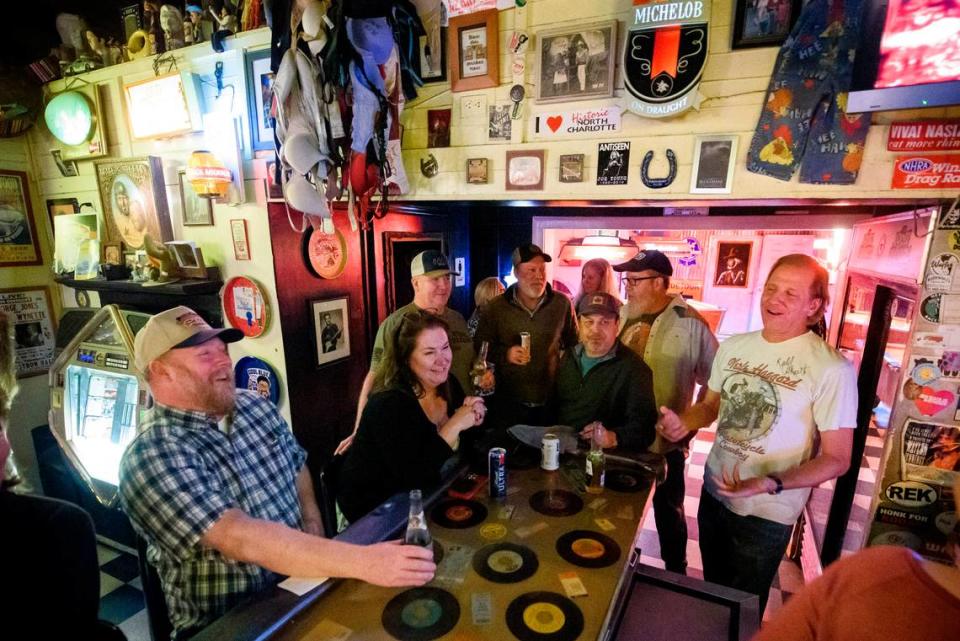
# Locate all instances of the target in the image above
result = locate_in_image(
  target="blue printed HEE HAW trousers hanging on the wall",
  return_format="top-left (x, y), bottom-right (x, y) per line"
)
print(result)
top-left (747, 0), bottom-right (870, 185)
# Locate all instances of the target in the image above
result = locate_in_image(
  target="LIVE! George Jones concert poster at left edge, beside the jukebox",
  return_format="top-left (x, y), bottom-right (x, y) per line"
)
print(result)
top-left (0, 287), bottom-right (56, 378)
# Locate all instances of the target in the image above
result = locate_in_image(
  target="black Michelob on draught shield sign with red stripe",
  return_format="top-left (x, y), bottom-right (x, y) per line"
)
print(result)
top-left (623, 0), bottom-right (710, 118)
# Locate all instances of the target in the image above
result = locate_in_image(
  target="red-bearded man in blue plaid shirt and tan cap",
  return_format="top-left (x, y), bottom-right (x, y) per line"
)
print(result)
top-left (120, 307), bottom-right (436, 638)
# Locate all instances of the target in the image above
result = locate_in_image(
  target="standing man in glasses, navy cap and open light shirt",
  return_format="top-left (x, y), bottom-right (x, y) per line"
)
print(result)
top-left (613, 249), bottom-right (717, 574)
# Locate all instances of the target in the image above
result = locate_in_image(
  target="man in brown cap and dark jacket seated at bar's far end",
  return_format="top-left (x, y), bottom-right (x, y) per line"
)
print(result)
top-left (556, 292), bottom-right (657, 452)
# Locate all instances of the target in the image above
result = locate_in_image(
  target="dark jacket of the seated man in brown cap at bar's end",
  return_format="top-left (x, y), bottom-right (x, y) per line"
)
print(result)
top-left (554, 341), bottom-right (657, 452)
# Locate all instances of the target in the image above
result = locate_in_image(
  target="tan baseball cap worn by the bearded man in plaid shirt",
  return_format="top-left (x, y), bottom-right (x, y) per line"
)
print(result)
top-left (133, 305), bottom-right (243, 372)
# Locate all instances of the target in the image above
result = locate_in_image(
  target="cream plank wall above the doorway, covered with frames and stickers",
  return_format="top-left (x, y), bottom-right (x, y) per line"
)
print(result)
top-left (401, 0), bottom-right (960, 200)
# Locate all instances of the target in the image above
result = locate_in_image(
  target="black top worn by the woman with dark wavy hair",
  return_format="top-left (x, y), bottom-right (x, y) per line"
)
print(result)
top-left (336, 376), bottom-right (464, 522)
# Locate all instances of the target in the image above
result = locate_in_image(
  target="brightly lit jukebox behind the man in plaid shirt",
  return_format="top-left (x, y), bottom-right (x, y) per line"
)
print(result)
top-left (49, 305), bottom-right (150, 507)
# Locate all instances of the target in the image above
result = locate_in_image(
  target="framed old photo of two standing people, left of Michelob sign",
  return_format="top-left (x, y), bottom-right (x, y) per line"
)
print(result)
top-left (536, 20), bottom-right (617, 102)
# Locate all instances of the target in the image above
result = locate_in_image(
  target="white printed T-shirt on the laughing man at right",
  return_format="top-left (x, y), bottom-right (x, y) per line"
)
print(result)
top-left (704, 332), bottom-right (857, 524)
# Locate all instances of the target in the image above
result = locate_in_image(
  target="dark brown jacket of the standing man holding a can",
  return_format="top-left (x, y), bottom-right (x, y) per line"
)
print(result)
top-left (473, 285), bottom-right (577, 404)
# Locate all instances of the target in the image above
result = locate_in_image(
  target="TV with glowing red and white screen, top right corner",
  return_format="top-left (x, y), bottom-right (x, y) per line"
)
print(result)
top-left (847, 0), bottom-right (960, 113)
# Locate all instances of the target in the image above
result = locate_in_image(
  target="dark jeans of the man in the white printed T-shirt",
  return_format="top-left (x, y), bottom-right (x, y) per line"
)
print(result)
top-left (697, 489), bottom-right (793, 616)
